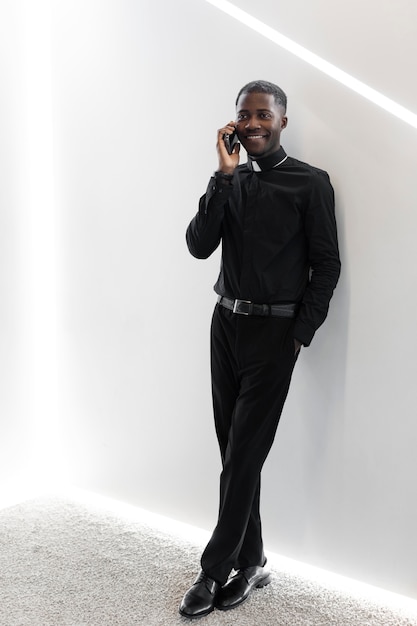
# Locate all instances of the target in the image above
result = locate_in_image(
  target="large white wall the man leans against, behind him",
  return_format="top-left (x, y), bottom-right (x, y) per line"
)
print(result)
top-left (2, 0), bottom-right (417, 597)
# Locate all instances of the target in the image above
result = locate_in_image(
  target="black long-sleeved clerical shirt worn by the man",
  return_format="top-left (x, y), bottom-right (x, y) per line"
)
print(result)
top-left (186, 147), bottom-right (340, 346)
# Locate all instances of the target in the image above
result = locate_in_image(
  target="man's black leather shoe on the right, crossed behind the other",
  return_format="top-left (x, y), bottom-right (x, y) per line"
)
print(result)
top-left (216, 565), bottom-right (271, 611)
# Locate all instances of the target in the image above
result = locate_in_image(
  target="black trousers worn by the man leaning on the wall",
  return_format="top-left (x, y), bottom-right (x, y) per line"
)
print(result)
top-left (201, 305), bottom-right (296, 585)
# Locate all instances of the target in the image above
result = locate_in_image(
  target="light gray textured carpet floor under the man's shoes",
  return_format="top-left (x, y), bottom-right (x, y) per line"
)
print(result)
top-left (0, 497), bottom-right (417, 626)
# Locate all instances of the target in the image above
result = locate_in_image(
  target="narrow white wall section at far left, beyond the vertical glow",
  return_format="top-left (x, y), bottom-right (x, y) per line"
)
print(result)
top-left (0, 2), bottom-right (31, 482)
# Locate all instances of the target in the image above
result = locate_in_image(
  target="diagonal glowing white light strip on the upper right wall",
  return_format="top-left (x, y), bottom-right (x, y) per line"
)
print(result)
top-left (202, 0), bottom-right (417, 128)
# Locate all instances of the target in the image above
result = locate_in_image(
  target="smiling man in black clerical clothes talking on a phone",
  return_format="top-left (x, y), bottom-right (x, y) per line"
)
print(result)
top-left (180, 81), bottom-right (340, 618)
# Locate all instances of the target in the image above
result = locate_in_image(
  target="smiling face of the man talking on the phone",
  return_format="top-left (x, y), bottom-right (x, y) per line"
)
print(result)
top-left (236, 93), bottom-right (287, 157)
